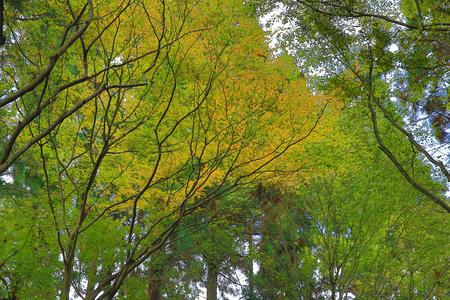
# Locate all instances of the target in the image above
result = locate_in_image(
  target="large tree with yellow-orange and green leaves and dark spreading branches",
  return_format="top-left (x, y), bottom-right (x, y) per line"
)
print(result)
top-left (0, 0), bottom-right (332, 299)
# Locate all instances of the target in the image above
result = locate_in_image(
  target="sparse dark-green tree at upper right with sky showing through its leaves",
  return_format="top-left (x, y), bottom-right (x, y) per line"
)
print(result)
top-left (257, 0), bottom-right (450, 212)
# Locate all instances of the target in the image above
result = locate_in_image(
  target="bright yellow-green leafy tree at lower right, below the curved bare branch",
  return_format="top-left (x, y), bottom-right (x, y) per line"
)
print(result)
top-left (299, 106), bottom-right (448, 299)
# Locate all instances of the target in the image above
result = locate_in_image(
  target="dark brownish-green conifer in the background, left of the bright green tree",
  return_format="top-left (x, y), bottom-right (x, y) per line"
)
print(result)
top-left (249, 183), bottom-right (321, 299)
